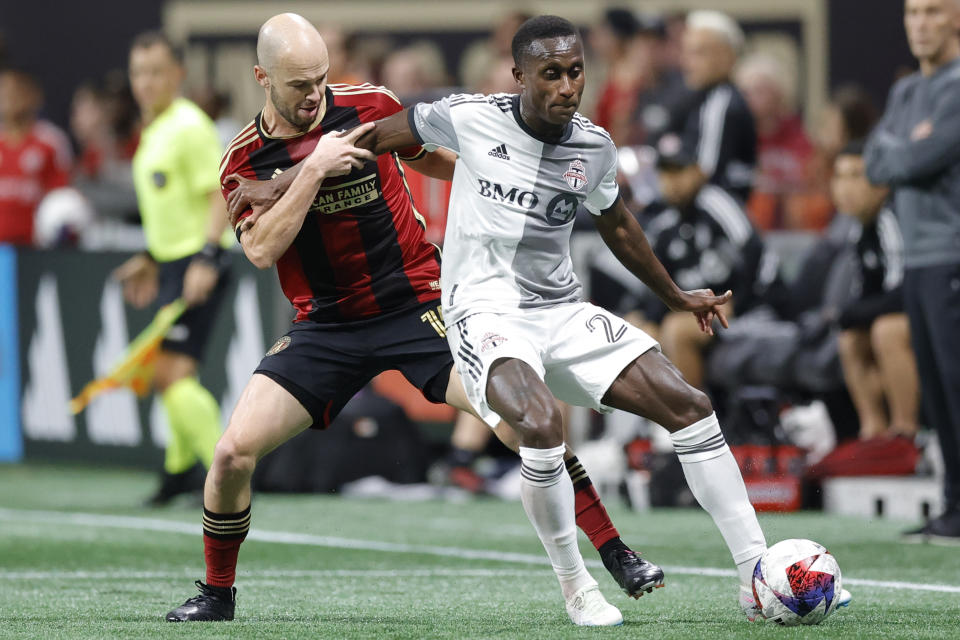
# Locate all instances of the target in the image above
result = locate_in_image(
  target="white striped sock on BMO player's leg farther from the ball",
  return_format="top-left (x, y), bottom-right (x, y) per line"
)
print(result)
top-left (520, 445), bottom-right (596, 600)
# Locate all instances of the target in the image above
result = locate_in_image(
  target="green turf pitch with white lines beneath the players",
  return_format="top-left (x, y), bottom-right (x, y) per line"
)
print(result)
top-left (0, 465), bottom-right (960, 640)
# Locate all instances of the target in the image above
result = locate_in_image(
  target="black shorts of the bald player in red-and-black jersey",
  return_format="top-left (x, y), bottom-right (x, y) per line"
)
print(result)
top-left (254, 300), bottom-right (453, 429)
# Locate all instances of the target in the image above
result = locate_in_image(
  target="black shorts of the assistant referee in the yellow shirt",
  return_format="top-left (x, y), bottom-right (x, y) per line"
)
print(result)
top-left (157, 251), bottom-right (230, 362)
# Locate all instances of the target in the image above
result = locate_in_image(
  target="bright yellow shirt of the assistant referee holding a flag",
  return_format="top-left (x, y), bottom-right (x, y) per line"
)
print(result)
top-left (133, 98), bottom-right (221, 262)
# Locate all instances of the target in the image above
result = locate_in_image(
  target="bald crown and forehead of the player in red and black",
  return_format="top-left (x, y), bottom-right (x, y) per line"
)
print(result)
top-left (257, 13), bottom-right (328, 73)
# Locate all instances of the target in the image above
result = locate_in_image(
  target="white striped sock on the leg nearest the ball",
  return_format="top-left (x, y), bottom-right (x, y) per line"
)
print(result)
top-left (670, 413), bottom-right (767, 585)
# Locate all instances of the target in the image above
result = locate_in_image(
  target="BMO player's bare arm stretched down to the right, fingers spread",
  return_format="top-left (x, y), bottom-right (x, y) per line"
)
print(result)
top-left (595, 198), bottom-right (733, 335)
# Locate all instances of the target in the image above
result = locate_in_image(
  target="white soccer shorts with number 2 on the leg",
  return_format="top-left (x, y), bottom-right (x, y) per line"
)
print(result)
top-left (447, 302), bottom-right (660, 427)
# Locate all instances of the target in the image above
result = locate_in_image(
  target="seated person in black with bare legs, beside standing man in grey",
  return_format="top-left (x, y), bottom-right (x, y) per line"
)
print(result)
top-left (833, 141), bottom-right (920, 440)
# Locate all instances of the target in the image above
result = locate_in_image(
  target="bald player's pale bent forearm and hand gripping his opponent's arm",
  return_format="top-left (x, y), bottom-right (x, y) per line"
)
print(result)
top-left (233, 124), bottom-right (377, 269)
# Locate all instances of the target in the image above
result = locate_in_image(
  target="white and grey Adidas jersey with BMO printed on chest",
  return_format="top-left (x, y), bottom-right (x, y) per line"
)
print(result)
top-left (410, 94), bottom-right (619, 326)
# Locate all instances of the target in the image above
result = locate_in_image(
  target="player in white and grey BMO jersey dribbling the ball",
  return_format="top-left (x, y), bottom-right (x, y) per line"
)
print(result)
top-left (227, 16), bottom-right (816, 625)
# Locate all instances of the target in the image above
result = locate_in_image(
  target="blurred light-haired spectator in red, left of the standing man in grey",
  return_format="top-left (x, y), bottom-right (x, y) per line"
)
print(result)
top-left (736, 53), bottom-right (816, 229)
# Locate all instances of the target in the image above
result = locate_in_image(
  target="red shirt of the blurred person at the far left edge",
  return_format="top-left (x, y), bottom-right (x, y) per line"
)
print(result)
top-left (0, 121), bottom-right (71, 245)
